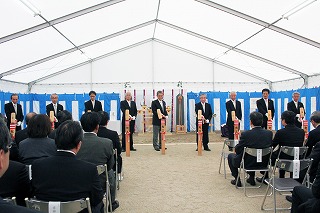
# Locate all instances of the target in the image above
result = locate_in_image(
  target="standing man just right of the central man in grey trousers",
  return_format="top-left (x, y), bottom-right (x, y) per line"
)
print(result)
top-left (195, 94), bottom-right (212, 151)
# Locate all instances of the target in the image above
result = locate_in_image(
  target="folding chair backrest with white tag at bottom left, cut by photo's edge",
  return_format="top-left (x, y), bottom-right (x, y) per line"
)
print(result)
top-left (25, 198), bottom-right (92, 213)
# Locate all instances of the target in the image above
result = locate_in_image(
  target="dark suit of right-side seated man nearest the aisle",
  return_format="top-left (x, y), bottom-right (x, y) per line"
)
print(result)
top-left (228, 127), bottom-right (272, 178)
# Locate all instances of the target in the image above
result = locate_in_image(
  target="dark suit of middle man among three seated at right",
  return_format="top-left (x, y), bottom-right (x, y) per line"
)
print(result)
top-left (272, 124), bottom-right (304, 178)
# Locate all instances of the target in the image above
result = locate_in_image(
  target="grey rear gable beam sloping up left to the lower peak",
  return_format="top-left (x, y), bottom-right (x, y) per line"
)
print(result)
top-left (28, 39), bottom-right (151, 85)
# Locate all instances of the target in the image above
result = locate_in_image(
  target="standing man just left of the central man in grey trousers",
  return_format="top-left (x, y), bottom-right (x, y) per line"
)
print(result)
top-left (120, 92), bottom-right (138, 152)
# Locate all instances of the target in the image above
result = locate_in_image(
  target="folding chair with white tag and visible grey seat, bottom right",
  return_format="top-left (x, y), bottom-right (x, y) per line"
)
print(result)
top-left (261, 159), bottom-right (312, 212)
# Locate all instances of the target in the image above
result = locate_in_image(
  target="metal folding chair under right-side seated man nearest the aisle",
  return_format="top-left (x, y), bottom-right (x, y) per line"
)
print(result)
top-left (236, 147), bottom-right (272, 197)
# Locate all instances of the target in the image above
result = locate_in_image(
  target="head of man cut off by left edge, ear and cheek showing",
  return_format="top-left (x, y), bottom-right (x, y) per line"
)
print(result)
top-left (0, 118), bottom-right (11, 177)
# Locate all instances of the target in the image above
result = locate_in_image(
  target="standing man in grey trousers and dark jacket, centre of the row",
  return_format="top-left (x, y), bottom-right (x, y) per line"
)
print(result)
top-left (151, 90), bottom-right (168, 151)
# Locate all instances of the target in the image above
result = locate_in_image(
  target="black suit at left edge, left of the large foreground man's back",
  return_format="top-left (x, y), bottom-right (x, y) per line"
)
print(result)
top-left (0, 161), bottom-right (31, 206)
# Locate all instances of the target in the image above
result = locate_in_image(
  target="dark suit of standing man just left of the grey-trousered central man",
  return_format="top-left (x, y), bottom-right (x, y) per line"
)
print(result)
top-left (120, 100), bottom-right (138, 149)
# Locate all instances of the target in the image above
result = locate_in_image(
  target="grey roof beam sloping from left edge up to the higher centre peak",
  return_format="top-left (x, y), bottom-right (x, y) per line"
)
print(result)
top-left (0, 20), bottom-right (155, 79)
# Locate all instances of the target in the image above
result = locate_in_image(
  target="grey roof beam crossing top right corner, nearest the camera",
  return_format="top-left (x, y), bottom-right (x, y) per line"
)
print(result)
top-left (195, 0), bottom-right (320, 48)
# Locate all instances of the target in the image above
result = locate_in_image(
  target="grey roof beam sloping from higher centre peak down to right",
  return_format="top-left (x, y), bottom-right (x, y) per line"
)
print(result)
top-left (157, 20), bottom-right (307, 78)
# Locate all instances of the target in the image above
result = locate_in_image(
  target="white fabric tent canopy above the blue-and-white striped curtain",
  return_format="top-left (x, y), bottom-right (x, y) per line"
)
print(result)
top-left (0, 0), bottom-right (320, 91)
